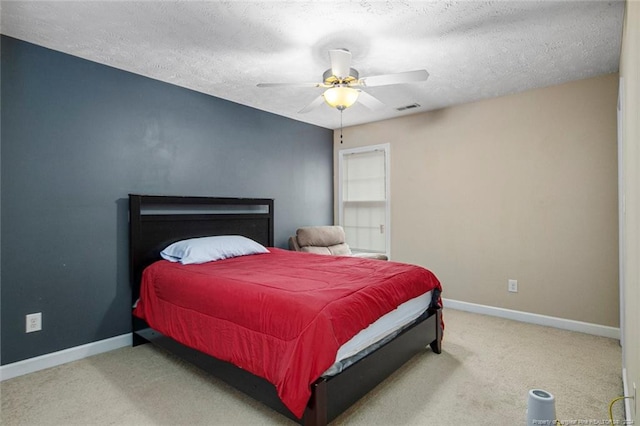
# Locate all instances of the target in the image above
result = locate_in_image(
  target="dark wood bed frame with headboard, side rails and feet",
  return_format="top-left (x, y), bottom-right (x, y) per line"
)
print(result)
top-left (129, 194), bottom-right (442, 425)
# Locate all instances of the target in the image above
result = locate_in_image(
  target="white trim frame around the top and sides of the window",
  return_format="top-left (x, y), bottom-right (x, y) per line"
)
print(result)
top-left (338, 143), bottom-right (391, 259)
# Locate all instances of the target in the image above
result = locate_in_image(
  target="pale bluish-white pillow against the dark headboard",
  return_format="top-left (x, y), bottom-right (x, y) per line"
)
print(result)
top-left (160, 235), bottom-right (269, 265)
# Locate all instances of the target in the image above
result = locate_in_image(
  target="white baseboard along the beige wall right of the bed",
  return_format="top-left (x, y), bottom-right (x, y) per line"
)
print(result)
top-left (442, 298), bottom-right (620, 340)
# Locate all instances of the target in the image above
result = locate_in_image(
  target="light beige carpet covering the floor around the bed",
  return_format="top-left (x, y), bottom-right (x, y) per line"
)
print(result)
top-left (0, 309), bottom-right (623, 426)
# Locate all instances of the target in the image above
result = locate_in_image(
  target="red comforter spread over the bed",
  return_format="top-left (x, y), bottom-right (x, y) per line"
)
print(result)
top-left (134, 248), bottom-right (441, 417)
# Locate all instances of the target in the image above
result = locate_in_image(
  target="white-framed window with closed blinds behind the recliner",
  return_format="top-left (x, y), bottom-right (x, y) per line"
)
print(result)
top-left (338, 144), bottom-right (390, 257)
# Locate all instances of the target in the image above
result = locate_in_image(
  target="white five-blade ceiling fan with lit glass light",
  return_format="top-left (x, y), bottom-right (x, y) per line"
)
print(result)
top-left (258, 49), bottom-right (429, 113)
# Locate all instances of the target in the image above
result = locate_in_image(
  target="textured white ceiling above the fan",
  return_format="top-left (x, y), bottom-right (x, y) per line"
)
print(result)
top-left (0, 0), bottom-right (624, 129)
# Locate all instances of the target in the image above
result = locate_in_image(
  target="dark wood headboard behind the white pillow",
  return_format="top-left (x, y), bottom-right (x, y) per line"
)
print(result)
top-left (129, 194), bottom-right (273, 303)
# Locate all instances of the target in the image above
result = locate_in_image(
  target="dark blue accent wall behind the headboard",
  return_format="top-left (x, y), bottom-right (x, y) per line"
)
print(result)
top-left (0, 36), bottom-right (333, 365)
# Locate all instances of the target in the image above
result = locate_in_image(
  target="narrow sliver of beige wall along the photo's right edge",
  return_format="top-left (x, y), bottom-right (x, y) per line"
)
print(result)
top-left (620, 1), bottom-right (640, 423)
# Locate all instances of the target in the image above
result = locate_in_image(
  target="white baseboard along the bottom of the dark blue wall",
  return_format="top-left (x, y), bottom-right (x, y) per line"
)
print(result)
top-left (0, 333), bottom-right (133, 381)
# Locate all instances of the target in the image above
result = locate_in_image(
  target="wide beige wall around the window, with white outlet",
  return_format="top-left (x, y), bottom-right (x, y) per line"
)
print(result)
top-left (334, 74), bottom-right (619, 327)
